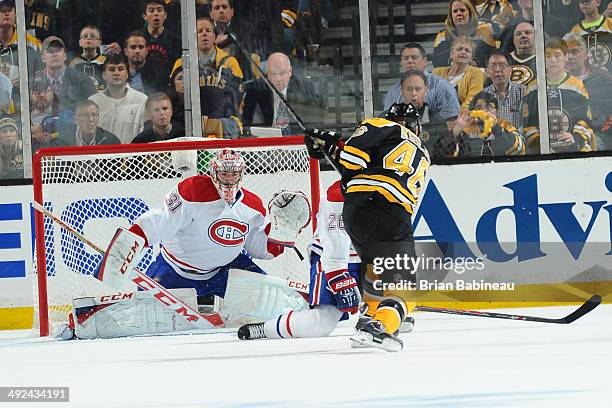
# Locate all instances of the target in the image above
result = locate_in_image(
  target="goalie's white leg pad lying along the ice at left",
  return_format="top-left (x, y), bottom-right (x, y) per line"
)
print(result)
top-left (72, 288), bottom-right (197, 339)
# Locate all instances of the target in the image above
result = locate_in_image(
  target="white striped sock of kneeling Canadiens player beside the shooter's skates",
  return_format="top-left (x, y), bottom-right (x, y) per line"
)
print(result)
top-left (264, 305), bottom-right (342, 339)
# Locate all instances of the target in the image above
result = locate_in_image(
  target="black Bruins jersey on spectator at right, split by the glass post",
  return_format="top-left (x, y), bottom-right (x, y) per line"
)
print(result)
top-left (523, 73), bottom-right (595, 152)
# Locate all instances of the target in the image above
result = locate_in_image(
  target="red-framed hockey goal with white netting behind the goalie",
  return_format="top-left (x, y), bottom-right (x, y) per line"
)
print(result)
top-left (32, 137), bottom-right (320, 337)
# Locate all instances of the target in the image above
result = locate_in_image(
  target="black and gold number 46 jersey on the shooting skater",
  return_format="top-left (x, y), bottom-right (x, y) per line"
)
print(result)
top-left (340, 118), bottom-right (430, 223)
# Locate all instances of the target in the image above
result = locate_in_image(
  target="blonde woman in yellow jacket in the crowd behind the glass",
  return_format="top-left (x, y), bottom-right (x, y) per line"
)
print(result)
top-left (433, 35), bottom-right (486, 109)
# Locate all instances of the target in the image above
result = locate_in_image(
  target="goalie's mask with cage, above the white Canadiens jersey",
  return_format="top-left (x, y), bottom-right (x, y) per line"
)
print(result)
top-left (210, 149), bottom-right (245, 204)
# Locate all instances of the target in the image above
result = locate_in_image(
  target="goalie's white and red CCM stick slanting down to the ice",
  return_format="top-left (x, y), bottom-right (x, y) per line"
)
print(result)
top-left (32, 202), bottom-right (223, 329)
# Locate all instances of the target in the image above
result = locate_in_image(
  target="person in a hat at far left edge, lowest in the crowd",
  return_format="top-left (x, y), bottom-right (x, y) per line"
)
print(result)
top-left (0, 114), bottom-right (23, 179)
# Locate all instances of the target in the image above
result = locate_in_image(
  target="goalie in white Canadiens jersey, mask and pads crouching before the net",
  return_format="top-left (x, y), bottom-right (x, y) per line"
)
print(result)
top-left (62, 150), bottom-right (311, 338)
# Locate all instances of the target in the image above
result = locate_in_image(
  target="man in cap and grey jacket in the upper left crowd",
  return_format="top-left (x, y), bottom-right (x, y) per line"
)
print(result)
top-left (36, 36), bottom-right (96, 112)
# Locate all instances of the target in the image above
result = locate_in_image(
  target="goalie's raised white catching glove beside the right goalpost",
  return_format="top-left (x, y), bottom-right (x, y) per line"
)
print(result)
top-left (268, 190), bottom-right (311, 247)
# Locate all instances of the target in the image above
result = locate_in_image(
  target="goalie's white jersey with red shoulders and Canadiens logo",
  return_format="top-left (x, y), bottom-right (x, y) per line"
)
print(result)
top-left (130, 175), bottom-right (278, 280)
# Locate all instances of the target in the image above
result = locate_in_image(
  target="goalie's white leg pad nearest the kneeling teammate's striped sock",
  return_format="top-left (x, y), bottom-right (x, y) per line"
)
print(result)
top-left (219, 269), bottom-right (308, 326)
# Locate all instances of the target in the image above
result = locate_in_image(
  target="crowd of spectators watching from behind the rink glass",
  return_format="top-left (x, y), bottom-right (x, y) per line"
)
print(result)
top-left (0, 0), bottom-right (612, 178)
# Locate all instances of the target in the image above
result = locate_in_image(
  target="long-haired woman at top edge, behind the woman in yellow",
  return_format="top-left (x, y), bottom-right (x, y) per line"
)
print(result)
top-left (431, 0), bottom-right (497, 67)
